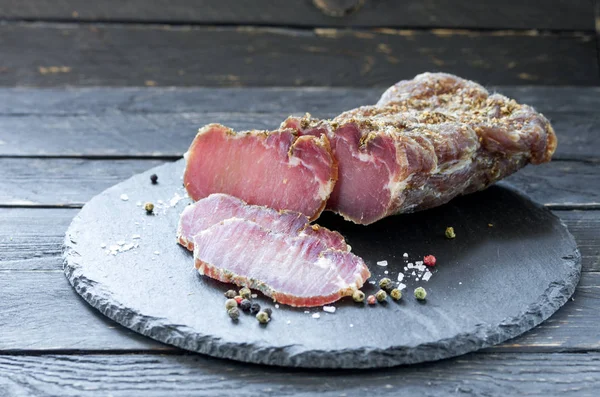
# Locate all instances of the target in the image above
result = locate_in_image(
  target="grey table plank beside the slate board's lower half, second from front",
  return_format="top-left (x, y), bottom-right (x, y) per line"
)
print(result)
top-left (0, 271), bottom-right (600, 354)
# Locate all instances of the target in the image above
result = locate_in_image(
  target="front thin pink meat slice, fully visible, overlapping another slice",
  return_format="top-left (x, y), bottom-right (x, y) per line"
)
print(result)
top-left (194, 218), bottom-right (370, 307)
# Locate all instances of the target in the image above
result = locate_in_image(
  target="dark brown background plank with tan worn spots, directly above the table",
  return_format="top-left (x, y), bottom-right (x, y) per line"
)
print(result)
top-left (0, 22), bottom-right (600, 87)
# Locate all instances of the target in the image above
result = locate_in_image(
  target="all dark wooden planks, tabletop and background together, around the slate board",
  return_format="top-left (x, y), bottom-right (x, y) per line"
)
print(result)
top-left (0, 0), bottom-right (600, 397)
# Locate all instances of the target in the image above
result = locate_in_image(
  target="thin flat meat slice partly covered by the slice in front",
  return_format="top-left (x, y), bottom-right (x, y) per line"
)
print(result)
top-left (177, 193), bottom-right (349, 251)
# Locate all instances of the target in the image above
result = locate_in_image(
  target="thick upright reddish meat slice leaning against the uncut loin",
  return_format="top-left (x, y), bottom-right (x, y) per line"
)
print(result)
top-left (184, 124), bottom-right (337, 220)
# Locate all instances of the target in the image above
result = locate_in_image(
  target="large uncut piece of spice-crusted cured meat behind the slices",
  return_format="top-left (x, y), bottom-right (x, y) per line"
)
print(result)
top-left (281, 73), bottom-right (557, 224)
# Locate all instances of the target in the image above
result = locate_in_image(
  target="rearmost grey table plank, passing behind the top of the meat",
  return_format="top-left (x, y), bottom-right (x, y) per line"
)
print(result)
top-left (0, 87), bottom-right (600, 160)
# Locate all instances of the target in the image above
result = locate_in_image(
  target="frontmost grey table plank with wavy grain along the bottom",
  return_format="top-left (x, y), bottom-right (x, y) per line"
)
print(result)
top-left (0, 353), bottom-right (600, 397)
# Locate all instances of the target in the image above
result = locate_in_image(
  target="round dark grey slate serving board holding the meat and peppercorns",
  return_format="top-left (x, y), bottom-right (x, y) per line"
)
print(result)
top-left (64, 161), bottom-right (581, 368)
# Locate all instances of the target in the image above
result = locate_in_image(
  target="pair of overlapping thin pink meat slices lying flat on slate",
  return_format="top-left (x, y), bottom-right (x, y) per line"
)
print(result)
top-left (177, 194), bottom-right (370, 307)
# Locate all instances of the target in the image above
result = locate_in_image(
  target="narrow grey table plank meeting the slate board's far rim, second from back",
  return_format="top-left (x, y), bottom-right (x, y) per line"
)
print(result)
top-left (0, 158), bottom-right (600, 206)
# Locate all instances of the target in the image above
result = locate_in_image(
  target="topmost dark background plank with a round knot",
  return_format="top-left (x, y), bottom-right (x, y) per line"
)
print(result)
top-left (0, 0), bottom-right (593, 30)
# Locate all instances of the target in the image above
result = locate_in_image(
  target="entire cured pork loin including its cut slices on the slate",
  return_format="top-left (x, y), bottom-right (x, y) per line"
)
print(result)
top-left (180, 73), bottom-right (556, 305)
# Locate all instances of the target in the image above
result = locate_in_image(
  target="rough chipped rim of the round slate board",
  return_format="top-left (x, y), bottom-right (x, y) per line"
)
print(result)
top-left (63, 160), bottom-right (581, 368)
